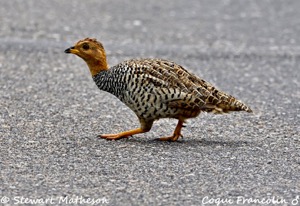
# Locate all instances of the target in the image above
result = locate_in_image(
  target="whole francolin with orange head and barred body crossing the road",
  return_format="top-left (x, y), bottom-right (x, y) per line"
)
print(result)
top-left (65, 38), bottom-right (252, 142)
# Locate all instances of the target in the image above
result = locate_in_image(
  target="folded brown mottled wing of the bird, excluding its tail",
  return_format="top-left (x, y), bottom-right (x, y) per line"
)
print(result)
top-left (126, 59), bottom-right (213, 110)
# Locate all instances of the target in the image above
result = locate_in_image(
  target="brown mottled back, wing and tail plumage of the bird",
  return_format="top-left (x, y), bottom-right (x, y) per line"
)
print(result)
top-left (126, 59), bottom-right (251, 113)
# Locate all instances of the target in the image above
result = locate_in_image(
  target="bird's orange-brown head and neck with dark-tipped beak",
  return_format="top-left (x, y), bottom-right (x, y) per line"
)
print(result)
top-left (65, 38), bottom-right (108, 76)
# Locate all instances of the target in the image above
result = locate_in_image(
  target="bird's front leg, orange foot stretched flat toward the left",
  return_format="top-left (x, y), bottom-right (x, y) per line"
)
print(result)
top-left (99, 119), bottom-right (153, 140)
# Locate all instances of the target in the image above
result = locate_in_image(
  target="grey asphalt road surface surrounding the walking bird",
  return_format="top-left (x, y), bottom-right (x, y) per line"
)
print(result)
top-left (0, 0), bottom-right (300, 205)
